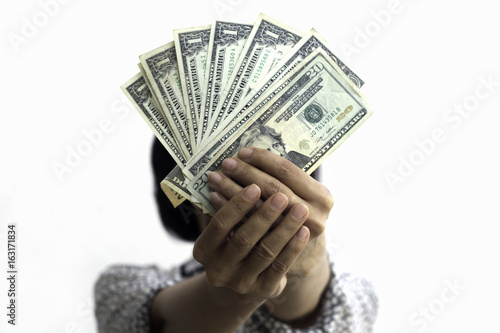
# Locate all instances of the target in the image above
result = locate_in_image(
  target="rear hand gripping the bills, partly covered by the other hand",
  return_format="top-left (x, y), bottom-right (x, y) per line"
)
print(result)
top-left (208, 148), bottom-right (333, 276)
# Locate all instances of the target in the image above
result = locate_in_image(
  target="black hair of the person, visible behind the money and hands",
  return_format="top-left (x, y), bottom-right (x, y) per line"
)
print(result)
top-left (152, 138), bottom-right (320, 242)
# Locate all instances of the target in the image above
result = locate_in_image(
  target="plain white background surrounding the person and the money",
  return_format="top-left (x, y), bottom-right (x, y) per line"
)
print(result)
top-left (0, 0), bottom-right (500, 333)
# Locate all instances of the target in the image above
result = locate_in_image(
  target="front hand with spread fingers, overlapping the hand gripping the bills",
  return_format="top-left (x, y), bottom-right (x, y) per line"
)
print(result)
top-left (193, 184), bottom-right (309, 302)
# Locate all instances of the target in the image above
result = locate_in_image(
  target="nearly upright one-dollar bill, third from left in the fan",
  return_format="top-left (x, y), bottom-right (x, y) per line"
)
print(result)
top-left (174, 25), bottom-right (210, 148)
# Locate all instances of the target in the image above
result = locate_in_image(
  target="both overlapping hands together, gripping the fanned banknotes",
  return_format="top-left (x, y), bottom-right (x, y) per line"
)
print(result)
top-left (193, 148), bottom-right (333, 300)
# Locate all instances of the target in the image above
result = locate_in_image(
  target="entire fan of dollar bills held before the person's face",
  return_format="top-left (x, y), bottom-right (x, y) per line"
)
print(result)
top-left (121, 14), bottom-right (371, 213)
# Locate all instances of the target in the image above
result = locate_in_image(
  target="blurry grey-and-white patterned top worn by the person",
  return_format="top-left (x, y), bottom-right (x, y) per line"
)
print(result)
top-left (94, 260), bottom-right (378, 333)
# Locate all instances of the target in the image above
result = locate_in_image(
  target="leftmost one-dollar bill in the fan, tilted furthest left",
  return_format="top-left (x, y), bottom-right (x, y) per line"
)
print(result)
top-left (121, 73), bottom-right (186, 165)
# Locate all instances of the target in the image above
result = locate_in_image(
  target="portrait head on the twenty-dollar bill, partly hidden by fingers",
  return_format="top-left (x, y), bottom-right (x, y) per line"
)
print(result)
top-left (240, 124), bottom-right (289, 159)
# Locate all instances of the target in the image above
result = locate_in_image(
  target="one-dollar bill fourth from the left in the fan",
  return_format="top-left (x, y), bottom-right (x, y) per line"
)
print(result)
top-left (198, 21), bottom-right (253, 145)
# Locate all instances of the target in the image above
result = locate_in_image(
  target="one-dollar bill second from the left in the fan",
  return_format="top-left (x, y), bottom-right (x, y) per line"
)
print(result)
top-left (143, 42), bottom-right (194, 157)
